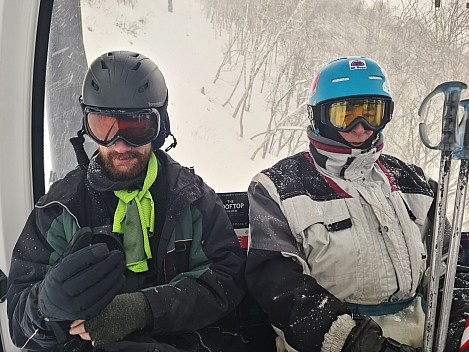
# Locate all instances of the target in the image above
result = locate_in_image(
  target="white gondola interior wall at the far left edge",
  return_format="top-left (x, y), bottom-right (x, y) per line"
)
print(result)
top-left (0, 0), bottom-right (42, 352)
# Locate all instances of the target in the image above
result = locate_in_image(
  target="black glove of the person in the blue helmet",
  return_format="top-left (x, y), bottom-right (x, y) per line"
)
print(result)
top-left (342, 317), bottom-right (422, 352)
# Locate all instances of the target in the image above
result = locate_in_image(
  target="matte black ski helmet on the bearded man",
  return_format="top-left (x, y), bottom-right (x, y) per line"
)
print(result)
top-left (81, 51), bottom-right (175, 150)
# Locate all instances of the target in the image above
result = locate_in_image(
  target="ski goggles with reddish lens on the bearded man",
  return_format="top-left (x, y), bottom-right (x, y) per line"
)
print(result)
top-left (83, 106), bottom-right (160, 147)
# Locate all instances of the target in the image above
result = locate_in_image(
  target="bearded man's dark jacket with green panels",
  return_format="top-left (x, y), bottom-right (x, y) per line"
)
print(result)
top-left (7, 151), bottom-right (245, 350)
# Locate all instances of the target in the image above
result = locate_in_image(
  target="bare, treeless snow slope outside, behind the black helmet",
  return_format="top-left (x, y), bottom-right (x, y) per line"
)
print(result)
top-left (82, 0), bottom-right (282, 192)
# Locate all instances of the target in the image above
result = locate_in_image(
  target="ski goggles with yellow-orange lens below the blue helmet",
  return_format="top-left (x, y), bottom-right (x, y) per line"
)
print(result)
top-left (321, 99), bottom-right (390, 132)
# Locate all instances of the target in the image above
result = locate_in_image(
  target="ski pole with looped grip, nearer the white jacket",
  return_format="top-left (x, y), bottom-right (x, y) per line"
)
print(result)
top-left (419, 81), bottom-right (467, 352)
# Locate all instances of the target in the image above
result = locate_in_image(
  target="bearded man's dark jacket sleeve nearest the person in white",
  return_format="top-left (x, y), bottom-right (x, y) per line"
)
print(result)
top-left (144, 185), bottom-right (245, 334)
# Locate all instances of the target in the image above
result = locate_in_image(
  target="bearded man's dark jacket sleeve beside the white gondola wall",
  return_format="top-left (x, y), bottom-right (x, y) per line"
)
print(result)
top-left (7, 208), bottom-right (82, 350)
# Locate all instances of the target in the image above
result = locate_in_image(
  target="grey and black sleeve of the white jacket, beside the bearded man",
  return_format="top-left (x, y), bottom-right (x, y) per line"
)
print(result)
top-left (246, 182), bottom-right (346, 351)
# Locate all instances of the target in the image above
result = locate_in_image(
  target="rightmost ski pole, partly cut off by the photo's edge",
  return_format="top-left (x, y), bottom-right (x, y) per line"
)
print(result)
top-left (436, 99), bottom-right (469, 352)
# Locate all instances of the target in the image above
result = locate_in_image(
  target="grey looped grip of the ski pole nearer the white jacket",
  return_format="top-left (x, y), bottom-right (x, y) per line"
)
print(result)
top-left (418, 81), bottom-right (467, 151)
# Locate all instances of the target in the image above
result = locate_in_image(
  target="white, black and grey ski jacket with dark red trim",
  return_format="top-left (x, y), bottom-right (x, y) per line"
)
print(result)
top-left (246, 133), bottom-right (464, 351)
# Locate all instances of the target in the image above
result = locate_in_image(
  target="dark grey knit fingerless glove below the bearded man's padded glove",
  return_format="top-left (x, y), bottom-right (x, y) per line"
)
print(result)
top-left (85, 292), bottom-right (153, 346)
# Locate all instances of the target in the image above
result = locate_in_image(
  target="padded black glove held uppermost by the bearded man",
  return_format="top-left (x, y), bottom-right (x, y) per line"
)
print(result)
top-left (38, 243), bottom-right (125, 321)
